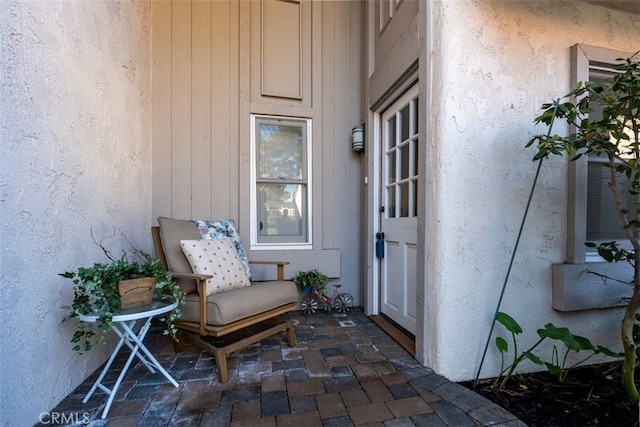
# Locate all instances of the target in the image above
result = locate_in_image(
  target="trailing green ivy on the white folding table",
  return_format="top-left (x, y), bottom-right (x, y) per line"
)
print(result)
top-left (60, 248), bottom-right (184, 354)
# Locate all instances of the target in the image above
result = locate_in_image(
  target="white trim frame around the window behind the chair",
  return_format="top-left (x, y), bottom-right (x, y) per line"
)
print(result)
top-left (249, 114), bottom-right (313, 250)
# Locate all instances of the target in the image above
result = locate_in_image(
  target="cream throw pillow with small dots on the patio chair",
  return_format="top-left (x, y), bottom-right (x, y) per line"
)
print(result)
top-left (180, 239), bottom-right (251, 295)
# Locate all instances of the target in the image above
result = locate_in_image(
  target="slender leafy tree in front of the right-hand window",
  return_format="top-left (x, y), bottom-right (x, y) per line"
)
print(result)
top-left (527, 56), bottom-right (640, 405)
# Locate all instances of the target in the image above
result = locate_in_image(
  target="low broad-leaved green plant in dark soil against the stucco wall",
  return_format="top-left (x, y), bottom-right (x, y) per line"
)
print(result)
top-left (493, 312), bottom-right (619, 389)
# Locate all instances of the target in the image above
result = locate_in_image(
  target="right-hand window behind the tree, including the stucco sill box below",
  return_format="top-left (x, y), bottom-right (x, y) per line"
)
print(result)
top-left (552, 45), bottom-right (633, 311)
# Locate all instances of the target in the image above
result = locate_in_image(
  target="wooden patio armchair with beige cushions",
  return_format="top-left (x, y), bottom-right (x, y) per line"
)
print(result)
top-left (152, 217), bottom-right (298, 383)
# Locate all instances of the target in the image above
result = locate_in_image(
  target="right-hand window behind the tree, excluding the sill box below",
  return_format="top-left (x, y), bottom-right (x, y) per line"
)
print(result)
top-left (567, 45), bottom-right (635, 264)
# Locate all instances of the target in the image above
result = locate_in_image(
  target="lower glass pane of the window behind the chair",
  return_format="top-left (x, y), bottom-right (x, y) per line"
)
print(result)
top-left (258, 183), bottom-right (307, 242)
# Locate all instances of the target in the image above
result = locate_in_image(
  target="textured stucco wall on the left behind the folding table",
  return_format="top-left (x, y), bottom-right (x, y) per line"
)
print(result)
top-left (0, 0), bottom-right (151, 426)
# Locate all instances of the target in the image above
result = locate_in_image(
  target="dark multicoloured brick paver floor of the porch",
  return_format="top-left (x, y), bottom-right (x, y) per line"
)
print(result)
top-left (46, 308), bottom-right (525, 427)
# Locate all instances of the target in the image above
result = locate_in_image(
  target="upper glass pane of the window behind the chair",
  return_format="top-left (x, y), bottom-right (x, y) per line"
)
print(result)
top-left (258, 123), bottom-right (305, 180)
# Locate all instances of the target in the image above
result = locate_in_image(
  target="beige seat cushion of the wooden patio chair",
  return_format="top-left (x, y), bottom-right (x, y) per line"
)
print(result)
top-left (180, 281), bottom-right (298, 326)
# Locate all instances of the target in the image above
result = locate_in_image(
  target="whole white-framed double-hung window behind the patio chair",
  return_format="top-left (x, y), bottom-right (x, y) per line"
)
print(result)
top-left (251, 114), bottom-right (312, 249)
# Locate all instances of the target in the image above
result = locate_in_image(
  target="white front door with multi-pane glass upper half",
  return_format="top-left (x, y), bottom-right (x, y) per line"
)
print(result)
top-left (380, 84), bottom-right (418, 334)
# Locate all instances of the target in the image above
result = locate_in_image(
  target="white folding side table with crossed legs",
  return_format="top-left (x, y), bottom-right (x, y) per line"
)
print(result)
top-left (78, 301), bottom-right (178, 419)
